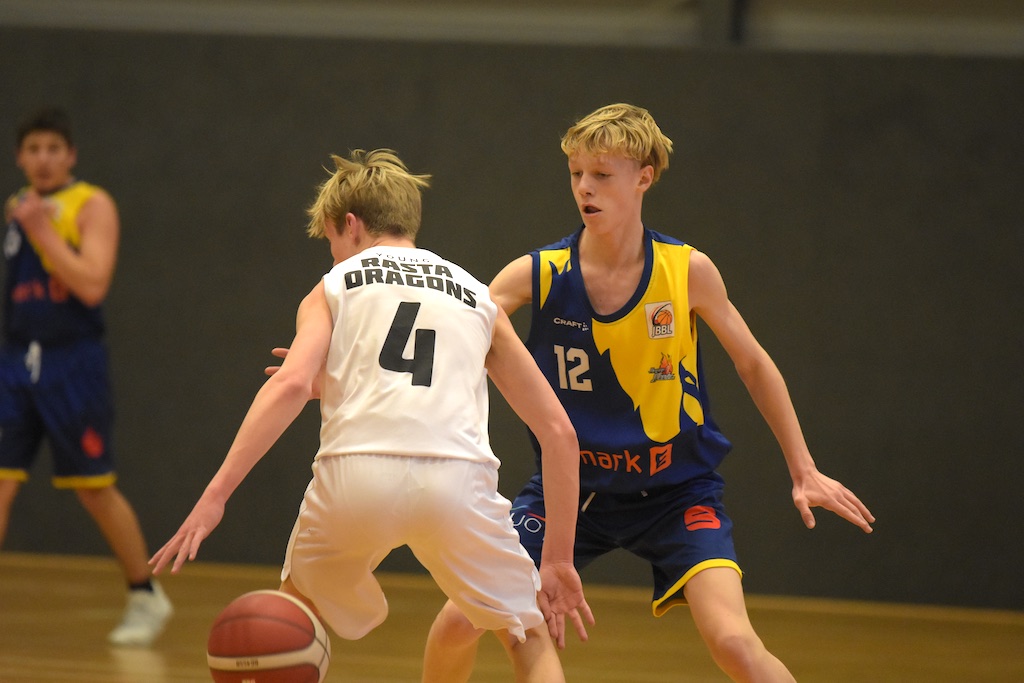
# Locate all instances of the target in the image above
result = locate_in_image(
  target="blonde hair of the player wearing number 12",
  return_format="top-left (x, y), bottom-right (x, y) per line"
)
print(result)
top-left (561, 103), bottom-right (672, 182)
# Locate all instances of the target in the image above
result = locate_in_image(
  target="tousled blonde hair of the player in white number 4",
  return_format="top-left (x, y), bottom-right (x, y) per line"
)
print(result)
top-left (306, 150), bottom-right (430, 240)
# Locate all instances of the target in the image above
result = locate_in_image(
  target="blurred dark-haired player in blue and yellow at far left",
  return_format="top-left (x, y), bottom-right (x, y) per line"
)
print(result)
top-left (0, 109), bottom-right (172, 645)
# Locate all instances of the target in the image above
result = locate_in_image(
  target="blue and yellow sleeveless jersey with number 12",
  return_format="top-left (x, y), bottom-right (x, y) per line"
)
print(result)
top-left (526, 229), bottom-right (731, 493)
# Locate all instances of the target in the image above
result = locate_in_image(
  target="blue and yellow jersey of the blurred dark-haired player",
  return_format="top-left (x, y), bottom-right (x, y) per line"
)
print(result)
top-left (3, 180), bottom-right (103, 346)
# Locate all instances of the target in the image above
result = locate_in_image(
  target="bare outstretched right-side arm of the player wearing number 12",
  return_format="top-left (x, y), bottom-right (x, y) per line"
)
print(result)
top-left (689, 250), bottom-right (874, 531)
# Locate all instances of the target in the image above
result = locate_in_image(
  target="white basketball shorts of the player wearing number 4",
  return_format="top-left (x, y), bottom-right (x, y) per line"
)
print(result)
top-left (282, 455), bottom-right (544, 641)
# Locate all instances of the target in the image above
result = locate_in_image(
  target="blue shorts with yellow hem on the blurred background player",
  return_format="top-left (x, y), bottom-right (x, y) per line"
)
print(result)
top-left (0, 340), bottom-right (115, 488)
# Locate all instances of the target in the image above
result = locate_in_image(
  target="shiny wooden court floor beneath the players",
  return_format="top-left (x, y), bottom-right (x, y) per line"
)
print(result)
top-left (0, 553), bottom-right (1024, 683)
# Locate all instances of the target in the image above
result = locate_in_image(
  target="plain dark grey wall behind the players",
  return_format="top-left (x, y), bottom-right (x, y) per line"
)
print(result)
top-left (0, 28), bottom-right (1024, 609)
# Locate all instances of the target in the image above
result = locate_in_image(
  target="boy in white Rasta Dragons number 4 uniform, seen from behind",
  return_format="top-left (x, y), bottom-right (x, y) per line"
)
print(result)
top-left (151, 150), bottom-right (590, 683)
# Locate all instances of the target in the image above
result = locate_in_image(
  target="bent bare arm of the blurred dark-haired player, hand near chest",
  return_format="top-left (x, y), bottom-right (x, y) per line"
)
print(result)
top-left (11, 189), bottom-right (121, 306)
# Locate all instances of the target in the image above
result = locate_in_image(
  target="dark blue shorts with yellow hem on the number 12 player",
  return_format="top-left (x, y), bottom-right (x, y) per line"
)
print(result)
top-left (512, 475), bottom-right (739, 616)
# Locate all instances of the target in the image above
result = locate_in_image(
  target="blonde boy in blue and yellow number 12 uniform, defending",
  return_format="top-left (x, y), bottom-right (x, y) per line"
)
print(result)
top-left (423, 104), bottom-right (874, 683)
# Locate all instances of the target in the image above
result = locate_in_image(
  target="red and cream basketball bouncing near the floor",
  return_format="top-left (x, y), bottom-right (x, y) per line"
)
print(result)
top-left (206, 591), bottom-right (331, 683)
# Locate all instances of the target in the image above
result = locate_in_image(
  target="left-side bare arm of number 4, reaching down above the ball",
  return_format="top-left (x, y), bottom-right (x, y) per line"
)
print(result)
top-left (150, 282), bottom-right (334, 573)
